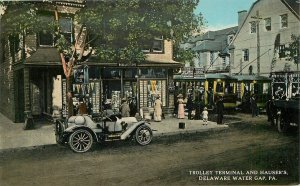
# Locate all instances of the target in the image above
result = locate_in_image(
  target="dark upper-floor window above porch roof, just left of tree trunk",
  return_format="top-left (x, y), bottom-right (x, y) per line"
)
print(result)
top-left (38, 15), bottom-right (54, 46)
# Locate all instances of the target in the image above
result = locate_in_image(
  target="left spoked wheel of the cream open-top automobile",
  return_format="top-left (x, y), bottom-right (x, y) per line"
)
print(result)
top-left (69, 129), bottom-right (93, 152)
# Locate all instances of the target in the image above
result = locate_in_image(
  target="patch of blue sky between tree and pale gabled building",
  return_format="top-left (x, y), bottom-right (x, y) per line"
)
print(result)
top-left (195, 0), bottom-right (256, 30)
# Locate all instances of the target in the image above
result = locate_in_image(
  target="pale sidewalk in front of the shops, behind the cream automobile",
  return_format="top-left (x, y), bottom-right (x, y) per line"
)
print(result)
top-left (0, 113), bottom-right (228, 150)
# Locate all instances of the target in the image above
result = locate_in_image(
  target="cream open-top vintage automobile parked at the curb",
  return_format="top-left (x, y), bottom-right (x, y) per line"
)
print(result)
top-left (55, 109), bottom-right (153, 153)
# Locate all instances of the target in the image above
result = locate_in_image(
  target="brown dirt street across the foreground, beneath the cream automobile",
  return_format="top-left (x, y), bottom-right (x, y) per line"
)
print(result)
top-left (0, 114), bottom-right (299, 186)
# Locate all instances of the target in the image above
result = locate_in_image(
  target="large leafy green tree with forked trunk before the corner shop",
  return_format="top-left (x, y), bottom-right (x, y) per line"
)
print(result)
top-left (1, 0), bottom-right (203, 117)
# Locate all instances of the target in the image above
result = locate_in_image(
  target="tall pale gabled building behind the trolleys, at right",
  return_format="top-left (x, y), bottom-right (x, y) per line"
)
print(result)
top-left (230, 0), bottom-right (300, 76)
